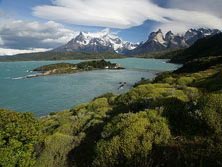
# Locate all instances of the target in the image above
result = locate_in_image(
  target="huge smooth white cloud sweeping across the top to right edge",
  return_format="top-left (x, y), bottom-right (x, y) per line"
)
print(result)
top-left (33, 0), bottom-right (222, 31)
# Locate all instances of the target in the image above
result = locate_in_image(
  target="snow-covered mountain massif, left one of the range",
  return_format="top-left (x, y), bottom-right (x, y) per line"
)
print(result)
top-left (55, 29), bottom-right (138, 53)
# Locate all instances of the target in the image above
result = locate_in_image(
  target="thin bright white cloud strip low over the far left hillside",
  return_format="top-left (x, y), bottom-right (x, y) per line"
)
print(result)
top-left (0, 48), bottom-right (51, 56)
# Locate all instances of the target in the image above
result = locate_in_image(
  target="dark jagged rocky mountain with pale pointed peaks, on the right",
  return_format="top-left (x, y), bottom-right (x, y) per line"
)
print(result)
top-left (128, 28), bottom-right (221, 55)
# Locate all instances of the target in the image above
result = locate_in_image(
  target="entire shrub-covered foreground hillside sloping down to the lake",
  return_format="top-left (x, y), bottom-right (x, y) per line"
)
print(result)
top-left (0, 33), bottom-right (222, 167)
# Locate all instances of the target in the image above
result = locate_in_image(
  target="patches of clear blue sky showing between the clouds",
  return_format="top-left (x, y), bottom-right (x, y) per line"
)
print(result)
top-left (0, 0), bottom-right (156, 42)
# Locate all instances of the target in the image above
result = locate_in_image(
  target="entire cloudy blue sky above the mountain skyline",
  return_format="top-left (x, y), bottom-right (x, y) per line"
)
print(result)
top-left (0, 0), bottom-right (222, 54)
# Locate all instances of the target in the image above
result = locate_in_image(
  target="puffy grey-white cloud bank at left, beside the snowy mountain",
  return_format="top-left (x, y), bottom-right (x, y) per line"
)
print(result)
top-left (0, 19), bottom-right (78, 50)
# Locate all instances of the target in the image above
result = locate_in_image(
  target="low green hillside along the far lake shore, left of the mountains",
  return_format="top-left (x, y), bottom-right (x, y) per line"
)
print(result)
top-left (0, 52), bottom-right (125, 62)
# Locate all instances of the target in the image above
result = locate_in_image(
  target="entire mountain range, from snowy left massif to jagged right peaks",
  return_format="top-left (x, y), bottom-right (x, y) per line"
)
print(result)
top-left (52, 28), bottom-right (221, 55)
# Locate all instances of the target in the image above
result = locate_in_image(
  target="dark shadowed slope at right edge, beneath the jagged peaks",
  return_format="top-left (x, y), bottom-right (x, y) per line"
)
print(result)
top-left (171, 33), bottom-right (222, 72)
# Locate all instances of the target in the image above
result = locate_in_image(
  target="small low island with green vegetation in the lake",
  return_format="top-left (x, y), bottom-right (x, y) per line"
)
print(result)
top-left (29, 60), bottom-right (124, 78)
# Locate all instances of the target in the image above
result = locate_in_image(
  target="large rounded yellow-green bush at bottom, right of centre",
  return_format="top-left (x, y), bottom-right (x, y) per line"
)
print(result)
top-left (93, 110), bottom-right (170, 167)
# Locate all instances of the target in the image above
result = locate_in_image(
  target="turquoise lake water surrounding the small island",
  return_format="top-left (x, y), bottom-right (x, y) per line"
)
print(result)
top-left (0, 58), bottom-right (178, 116)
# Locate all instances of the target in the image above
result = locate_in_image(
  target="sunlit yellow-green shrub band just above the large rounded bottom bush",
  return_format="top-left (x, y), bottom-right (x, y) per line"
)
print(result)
top-left (116, 83), bottom-right (199, 112)
